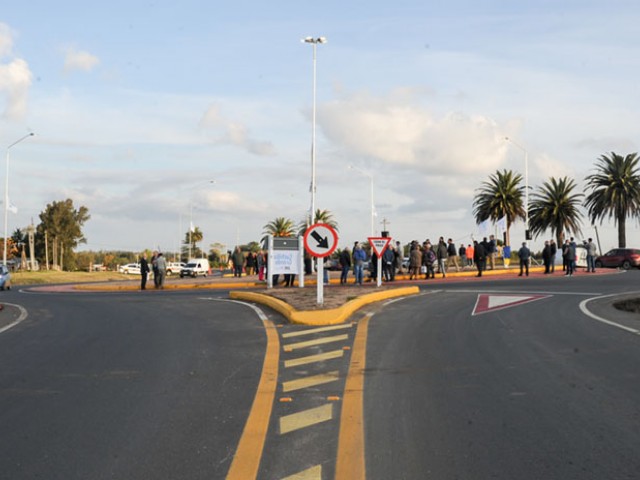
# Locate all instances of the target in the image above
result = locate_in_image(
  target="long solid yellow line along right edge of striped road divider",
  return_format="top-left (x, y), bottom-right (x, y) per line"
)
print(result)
top-left (336, 315), bottom-right (371, 480)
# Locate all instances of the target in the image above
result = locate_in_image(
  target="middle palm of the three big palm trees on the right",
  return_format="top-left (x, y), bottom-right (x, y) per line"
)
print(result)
top-left (529, 177), bottom-right (584, 245)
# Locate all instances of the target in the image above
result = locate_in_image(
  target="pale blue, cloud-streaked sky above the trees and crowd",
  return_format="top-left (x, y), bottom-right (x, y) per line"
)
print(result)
top-left (0, 0), bottom-right (640, 252)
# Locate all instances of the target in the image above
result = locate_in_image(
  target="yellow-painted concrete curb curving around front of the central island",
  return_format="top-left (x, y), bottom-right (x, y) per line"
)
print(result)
top-left (229, 287), bottom-right (420, 326)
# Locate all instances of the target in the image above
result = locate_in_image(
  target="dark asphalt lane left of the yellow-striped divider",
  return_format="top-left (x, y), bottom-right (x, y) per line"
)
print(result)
top-left (0, 290), bottom-right (265, 480)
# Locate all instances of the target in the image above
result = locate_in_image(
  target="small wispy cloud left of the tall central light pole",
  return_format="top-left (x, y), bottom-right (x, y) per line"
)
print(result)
top-left (200, 105), bottom-right (276, 156)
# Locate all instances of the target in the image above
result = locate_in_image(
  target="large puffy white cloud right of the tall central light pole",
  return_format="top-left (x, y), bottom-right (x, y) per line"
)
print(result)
top-left (318, 92), bottom-right (506, 174)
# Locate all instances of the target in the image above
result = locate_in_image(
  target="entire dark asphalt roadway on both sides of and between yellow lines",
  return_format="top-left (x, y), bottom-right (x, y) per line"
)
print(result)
top-left (0, 271), bottom-right (640, 480)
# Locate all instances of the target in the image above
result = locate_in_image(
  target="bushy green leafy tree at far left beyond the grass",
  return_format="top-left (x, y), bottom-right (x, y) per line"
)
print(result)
top-left (36, 198), bottom-right (91, 269)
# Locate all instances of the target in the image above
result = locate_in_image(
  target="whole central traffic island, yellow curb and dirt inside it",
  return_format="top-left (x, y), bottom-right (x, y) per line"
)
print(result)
top-left (229, 287), bottom-right (420, 326)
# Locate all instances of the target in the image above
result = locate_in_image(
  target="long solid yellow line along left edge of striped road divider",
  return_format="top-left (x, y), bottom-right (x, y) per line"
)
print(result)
top-left (227, 317), bottom-right (280, 480)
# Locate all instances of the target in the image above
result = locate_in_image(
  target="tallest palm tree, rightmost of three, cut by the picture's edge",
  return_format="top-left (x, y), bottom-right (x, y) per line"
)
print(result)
top-left (584, 152), bottom-right (640, 248)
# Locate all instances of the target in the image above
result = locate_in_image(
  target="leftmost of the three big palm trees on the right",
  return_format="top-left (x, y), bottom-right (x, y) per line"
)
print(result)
top-left (473, 170), bottom-right (526, 245)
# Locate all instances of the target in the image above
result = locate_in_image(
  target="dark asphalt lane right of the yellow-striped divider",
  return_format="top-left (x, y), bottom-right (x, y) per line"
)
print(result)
top-left (364, 271), bottom-right (640, 480)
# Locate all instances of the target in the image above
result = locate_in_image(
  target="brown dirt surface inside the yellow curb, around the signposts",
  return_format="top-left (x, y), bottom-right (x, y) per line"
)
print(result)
top-left (260, 285), bottom-right (394, 310)
